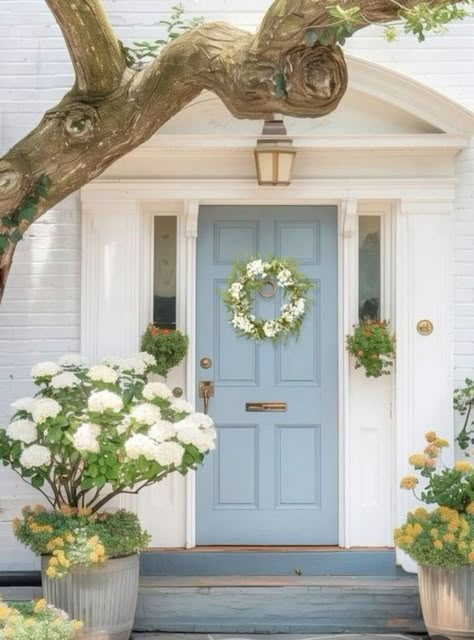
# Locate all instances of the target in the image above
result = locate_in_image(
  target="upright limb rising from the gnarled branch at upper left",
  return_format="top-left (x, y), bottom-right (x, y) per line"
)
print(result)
top-left (46, 0), bottom-right (126, 95)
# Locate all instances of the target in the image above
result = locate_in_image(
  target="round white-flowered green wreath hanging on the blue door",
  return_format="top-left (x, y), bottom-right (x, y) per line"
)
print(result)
top-left (223, 257), bottom-right (313, 343)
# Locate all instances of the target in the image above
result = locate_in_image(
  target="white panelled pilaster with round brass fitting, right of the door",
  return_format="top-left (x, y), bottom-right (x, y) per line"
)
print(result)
top-left (394, 200), bottom-right (454, 571)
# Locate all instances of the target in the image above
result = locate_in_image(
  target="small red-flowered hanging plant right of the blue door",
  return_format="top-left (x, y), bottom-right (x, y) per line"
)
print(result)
top-left (346, 320), bottom-right (395, 378)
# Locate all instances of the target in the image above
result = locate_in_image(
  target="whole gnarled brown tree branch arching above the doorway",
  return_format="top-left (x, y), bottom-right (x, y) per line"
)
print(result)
top-left (0, 0), bottom-right (468, 299)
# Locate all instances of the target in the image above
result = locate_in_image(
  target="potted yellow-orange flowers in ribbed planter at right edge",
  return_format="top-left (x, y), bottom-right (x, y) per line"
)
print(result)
top-left (395, 381), bottom-right (474, 640)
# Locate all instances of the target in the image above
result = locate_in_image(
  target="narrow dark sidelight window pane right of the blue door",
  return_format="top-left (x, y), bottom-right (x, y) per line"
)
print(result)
top-left (359, 216), bottom-right (381, 320)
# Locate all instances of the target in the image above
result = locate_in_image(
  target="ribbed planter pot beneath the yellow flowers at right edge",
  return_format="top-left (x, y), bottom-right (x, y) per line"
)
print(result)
top-left (418, 566), bottom-right (474, 640)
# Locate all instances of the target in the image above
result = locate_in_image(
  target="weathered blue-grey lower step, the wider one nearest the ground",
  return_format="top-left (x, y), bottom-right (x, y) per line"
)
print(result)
top-left (135, 575), bottom-right (425, 637)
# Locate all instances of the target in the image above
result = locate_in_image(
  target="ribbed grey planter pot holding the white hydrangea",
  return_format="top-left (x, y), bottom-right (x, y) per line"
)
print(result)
top-left (41, 554), bottom-right (139, 640)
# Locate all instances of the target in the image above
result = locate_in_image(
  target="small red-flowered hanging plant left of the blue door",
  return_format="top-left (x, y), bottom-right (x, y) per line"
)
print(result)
top-left (142, 323), bottom-right (189, 378)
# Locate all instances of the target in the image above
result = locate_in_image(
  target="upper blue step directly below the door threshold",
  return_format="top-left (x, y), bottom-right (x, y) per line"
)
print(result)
top-left (141, 547), bottom-right (403, 577)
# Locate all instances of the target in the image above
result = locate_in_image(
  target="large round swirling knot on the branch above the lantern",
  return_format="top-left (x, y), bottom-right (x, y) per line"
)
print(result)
top-left (282, 44), bottom-right (347, 117)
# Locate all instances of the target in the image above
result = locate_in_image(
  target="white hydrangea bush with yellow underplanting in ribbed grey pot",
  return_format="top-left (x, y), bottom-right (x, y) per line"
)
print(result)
top-left (0, 353), bottom-right (215, 640)
